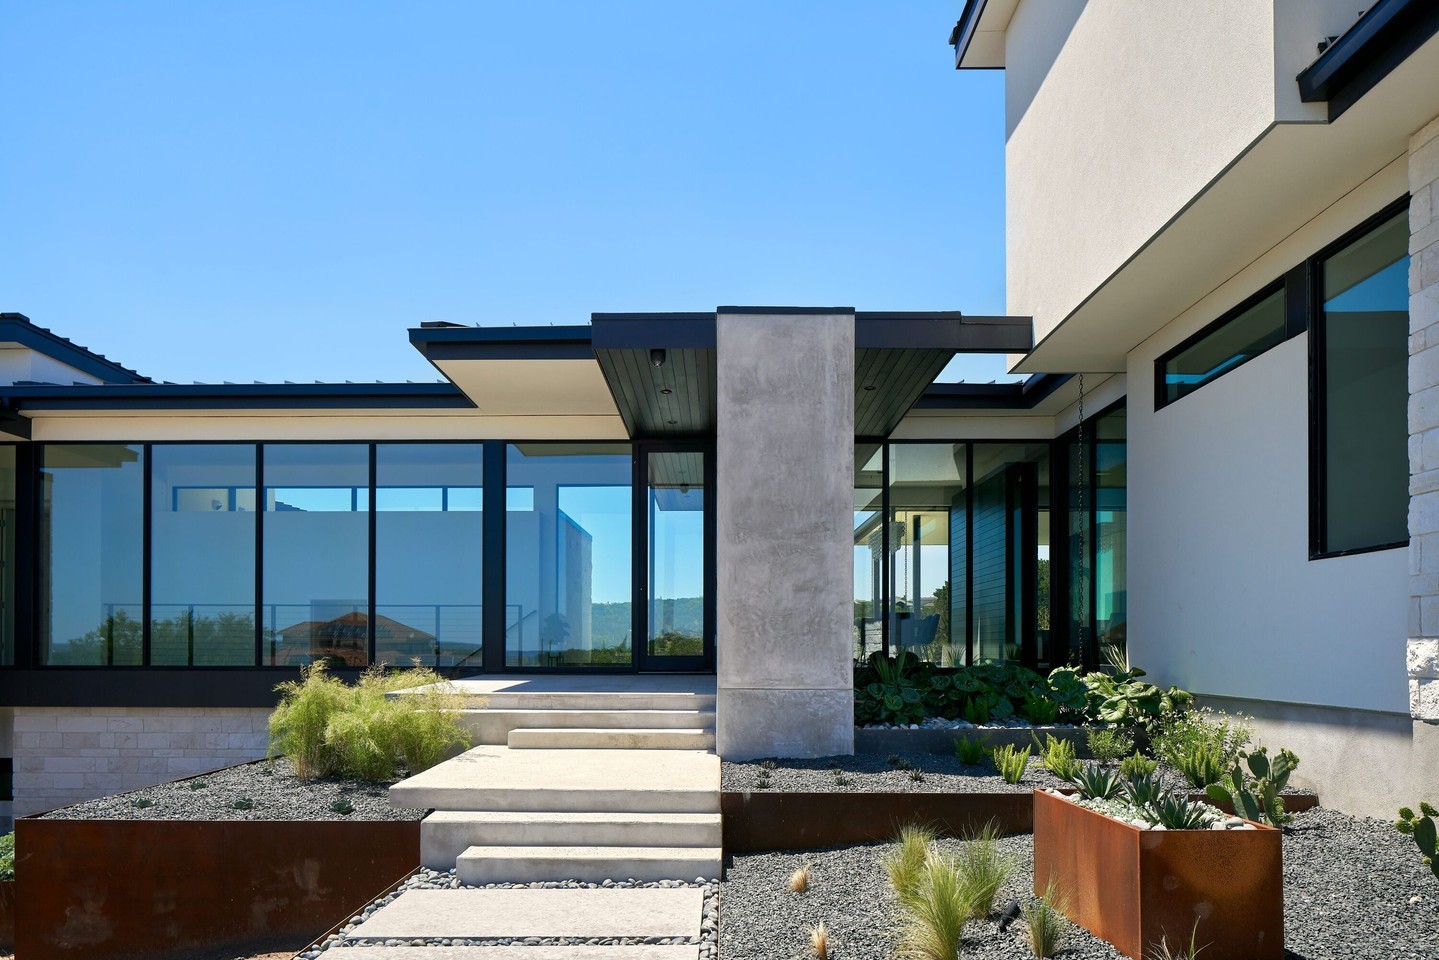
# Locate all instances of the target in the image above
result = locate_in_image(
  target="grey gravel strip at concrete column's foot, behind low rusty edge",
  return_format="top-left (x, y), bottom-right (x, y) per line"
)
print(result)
top-left (720, 753), bottom-right (1307, 793)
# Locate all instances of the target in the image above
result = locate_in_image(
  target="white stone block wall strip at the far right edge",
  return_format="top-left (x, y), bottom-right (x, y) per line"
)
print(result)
top-left (1406, 117), bottom-right (1439, 719)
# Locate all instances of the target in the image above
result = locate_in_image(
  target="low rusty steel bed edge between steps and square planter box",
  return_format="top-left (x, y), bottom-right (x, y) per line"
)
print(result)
top-left (720, 790), bottom-right (1033, 853)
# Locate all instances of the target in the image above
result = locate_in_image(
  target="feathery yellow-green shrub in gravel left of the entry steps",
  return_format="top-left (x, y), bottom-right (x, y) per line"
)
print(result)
top-left (269, 662), bottom-right (469, 780)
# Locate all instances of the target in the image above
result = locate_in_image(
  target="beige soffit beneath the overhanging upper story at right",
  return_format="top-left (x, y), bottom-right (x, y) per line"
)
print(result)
top-left (1012, 28), bottom-right (1439, 373)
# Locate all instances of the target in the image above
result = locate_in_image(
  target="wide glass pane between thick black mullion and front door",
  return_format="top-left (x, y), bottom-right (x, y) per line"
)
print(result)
top-left (505, 443), bottom-right (633, 668)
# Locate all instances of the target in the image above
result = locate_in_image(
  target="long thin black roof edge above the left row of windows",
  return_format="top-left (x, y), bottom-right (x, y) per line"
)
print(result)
top-left (0, 383), bottom-right (475, 410)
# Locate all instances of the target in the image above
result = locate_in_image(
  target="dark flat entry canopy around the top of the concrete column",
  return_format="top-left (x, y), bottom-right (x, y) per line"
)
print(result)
top-left (410, 307), bottom-right (1033, 439)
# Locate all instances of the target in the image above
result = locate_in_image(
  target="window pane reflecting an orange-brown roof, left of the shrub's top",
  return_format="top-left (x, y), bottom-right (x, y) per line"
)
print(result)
top-left (260, 443), bottom-right (370, 666)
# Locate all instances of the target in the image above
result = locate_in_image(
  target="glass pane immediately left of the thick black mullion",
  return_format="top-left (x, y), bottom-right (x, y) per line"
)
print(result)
top-left (374, 443), bottom-right (484, 668)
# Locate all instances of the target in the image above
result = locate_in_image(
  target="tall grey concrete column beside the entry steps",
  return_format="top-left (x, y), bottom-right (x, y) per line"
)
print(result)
top-left (715, 308), bottom-right (855, 760)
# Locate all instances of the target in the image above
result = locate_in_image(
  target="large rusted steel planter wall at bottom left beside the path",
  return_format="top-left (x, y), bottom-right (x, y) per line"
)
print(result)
top-left (14, 819), bottom-right (420, 960)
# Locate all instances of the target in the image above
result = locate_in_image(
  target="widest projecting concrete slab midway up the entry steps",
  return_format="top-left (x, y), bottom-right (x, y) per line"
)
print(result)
top-left (390, 744), bottom-right (720, 813)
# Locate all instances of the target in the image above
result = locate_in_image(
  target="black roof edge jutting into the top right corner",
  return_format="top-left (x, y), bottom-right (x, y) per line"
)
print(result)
top-left (1295, 0), bottom-right (1439, 122)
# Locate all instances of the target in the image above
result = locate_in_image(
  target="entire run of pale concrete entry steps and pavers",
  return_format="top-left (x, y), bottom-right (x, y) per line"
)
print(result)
top-left (305, 678), bottom-right (722, 960)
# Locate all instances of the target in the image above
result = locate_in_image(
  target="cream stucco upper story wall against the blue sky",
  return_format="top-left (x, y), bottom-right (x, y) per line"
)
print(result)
top-left (1004, 0), bottom-right (1357, 345)
